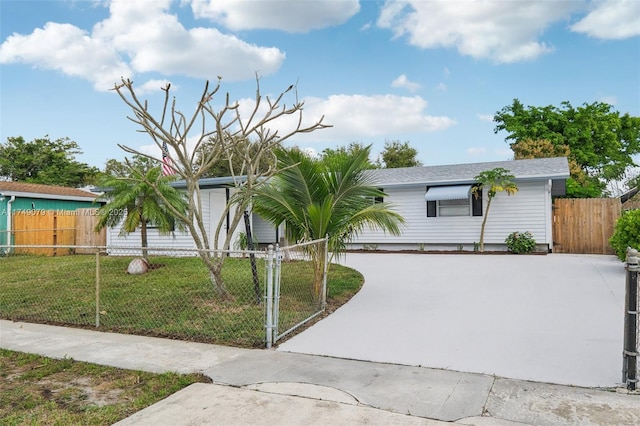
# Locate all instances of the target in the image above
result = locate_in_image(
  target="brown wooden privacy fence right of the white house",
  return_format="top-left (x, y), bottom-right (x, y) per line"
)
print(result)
top-left (553, 198), bottom-right (622, 254)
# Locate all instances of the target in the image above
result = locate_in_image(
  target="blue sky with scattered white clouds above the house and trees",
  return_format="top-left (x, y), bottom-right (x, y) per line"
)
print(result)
top-left (0, 0), bottom-right (640, 168)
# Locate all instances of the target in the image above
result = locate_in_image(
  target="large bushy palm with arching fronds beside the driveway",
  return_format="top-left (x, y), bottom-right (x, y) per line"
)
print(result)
top-left (253, 146), bottom-right (404, 297)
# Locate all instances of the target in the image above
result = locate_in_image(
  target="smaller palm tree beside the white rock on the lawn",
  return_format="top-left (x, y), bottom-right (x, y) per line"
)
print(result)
top-left (95, 166), bottom-right (187, 259)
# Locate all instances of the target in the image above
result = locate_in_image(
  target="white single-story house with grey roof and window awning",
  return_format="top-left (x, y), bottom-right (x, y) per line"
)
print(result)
top-left (107, 157), bottom-right (569, 255)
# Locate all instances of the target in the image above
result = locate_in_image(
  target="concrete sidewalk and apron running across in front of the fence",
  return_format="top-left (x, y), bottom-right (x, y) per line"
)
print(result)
top-left (0, 320), bottom-right (640, 426)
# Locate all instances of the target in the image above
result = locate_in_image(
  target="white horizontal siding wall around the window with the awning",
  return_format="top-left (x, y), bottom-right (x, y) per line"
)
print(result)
top-left (353, 181), bottom-right (552, 250)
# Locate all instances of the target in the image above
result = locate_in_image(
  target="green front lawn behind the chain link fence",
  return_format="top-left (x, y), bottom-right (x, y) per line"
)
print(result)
top-left (0, 255), bottom-right (363, 347)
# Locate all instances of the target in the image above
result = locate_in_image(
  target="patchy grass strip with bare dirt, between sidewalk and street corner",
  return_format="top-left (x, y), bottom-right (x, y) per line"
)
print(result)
top-left (0, 350), bottom-right (210, 425)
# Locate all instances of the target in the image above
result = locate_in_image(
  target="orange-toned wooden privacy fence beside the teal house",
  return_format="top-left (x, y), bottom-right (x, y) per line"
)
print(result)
top-left (12, 209), bottom-right (106, 256)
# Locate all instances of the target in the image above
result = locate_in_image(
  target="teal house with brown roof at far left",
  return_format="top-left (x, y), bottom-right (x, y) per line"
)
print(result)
top-left (0, 181), bottom-right (97, 246)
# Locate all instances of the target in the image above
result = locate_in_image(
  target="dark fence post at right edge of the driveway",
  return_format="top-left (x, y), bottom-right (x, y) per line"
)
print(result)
top-left (622, 248), bottom-right (640, 390)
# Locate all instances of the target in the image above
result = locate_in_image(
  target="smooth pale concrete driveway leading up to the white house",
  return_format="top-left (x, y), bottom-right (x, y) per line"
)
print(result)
top-left (278, 253), bottom-right (625, 387)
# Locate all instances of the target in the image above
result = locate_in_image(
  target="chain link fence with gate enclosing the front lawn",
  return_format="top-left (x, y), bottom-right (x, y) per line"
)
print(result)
top-left (0, 240), bottom-right (326, 347)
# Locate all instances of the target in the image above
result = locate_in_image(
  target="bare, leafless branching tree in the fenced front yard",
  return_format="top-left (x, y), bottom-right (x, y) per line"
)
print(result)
top-left (114, 76), bottom-right (331, 298)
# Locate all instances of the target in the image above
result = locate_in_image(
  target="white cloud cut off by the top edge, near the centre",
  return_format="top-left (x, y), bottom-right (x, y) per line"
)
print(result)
top-left (191, 0), bottom-right (360, 33)
